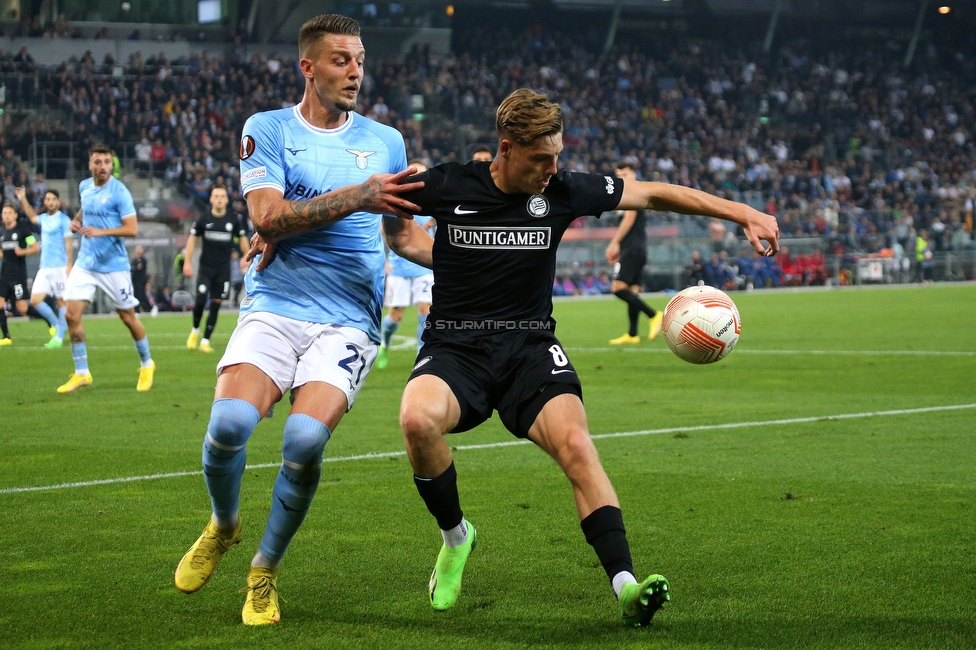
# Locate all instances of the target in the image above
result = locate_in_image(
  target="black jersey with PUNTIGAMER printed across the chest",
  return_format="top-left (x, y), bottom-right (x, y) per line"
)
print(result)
top-left (404, 162), bottom-right (623, 329)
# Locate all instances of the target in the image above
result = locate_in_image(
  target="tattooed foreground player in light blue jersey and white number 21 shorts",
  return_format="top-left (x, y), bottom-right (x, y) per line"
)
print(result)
top-left (175, 15), bottom-right (431, 625)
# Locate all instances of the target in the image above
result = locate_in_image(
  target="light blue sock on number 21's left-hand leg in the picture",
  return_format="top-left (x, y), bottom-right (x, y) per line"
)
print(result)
top-left (203, 398), bottom-right (261, 519)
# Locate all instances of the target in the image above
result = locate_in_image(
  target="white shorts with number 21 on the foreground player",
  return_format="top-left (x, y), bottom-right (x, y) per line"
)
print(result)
top-left (217, 311), bottom-right (379, 411)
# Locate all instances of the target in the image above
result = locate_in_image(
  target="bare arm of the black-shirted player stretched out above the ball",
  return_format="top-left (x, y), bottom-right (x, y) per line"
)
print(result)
top-left (617, 181), bottom-right (779, 255)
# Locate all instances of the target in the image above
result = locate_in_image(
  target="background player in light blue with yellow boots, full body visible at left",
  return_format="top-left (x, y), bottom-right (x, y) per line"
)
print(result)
top-left (58, 144), bottom-right (156, 393)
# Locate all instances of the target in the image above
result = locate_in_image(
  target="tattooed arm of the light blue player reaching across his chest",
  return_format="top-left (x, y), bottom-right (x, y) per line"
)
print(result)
top-left (247, 167), bottom-right (424, 243)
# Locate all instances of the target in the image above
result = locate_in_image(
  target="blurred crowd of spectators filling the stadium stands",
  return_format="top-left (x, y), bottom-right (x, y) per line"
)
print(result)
top-left (0, 20), bottom-right (976, 291)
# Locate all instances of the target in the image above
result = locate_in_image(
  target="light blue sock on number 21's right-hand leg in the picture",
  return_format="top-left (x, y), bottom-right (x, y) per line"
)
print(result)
top-left (261, 413), bottom-right (332, 560)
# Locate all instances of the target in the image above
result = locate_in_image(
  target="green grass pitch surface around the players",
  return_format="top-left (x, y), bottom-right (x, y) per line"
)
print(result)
top-left (0, 285), bottom-right (976, 649)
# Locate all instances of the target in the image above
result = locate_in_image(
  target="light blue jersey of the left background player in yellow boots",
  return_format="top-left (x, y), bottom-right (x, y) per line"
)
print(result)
top-left (78, 176), bottom-right (136, 273)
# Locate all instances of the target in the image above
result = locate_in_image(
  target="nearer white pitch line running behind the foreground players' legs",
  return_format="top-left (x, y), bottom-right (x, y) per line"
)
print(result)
top-left (0, 403), bottom-right (976, 494)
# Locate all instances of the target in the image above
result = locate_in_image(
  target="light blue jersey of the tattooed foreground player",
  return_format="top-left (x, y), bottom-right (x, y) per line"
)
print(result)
top-left (241, 106), bottom-right (407, 342)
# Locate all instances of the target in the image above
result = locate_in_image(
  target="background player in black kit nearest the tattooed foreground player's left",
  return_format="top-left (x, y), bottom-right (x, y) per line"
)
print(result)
top-left (183, 185), bottom-right (248, 352)
